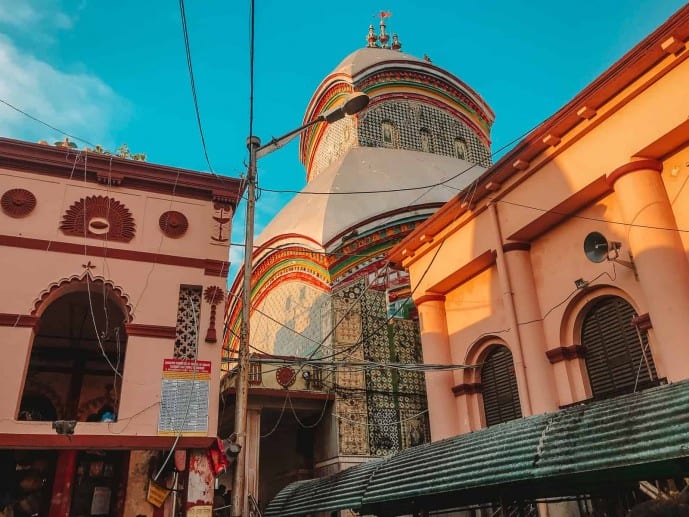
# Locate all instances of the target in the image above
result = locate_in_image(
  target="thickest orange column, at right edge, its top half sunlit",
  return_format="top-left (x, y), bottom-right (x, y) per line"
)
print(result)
top-left (608, 160), bottom-right (689, 382)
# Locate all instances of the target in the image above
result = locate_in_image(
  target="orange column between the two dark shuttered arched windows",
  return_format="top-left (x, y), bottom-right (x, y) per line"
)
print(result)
top-left (503, 242), bottom-right (559, 415)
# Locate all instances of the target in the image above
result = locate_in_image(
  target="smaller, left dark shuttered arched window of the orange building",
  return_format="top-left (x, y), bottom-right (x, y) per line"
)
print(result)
top-left (481, 346), bottom-right (522, 426)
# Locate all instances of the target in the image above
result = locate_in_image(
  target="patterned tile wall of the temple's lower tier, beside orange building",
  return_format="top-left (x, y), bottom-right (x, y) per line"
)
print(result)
top-left (333, 278), bottom-right (430, 456)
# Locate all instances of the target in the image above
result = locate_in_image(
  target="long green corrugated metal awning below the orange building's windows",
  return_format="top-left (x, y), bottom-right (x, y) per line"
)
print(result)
top-left (266, 381), bottom-right (689, 516)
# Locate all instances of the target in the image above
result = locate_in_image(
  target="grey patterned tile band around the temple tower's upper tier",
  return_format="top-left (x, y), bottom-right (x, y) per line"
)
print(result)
top-left (357, 100), bottom-right (491, 167)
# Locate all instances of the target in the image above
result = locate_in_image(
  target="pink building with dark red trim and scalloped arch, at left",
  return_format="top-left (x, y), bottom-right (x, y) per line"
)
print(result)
top-left (0, 138), bottom-right (241, 517)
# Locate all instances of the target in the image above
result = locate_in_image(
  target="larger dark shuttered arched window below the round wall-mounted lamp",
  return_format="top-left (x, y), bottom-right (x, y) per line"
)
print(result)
top-left (581, 296), bottom-right (658, 398)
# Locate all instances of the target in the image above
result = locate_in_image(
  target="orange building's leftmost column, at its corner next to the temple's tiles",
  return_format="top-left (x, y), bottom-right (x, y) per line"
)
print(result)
top-left (415, 294), bottom-right (460, 441)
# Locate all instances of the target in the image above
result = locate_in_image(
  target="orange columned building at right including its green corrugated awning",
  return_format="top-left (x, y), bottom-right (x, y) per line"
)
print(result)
top-left (267, 6), bottom-right (689, 516)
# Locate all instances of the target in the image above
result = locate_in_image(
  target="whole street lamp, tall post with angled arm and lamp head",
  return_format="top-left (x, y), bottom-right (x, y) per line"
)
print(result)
top-left (231, 92), bottom-right (369, 517)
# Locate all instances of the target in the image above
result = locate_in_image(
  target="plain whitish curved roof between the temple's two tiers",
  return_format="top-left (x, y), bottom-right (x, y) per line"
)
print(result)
top-left (257, 145), bottom-right (485, 248)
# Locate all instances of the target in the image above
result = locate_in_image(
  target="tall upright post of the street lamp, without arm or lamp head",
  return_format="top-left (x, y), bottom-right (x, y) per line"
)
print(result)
top-left (230, 136), bottom-right (261, 517)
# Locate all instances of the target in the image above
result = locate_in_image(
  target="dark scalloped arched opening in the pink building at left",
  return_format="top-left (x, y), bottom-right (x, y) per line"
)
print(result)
top-left (18, 278), bottom-right (129, 422)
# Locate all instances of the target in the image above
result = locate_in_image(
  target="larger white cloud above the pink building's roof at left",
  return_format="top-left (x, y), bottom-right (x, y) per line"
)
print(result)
top-left (0, 33), bottom-right (131, 147)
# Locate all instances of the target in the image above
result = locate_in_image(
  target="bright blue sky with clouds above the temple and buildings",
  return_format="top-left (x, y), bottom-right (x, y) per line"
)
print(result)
top-left (0, 0), bottom-right (684, 279)
